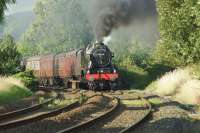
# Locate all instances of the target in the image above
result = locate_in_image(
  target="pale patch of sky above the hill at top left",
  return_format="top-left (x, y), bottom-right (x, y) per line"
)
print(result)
top-left (5, 0), bottom-right (37, 15)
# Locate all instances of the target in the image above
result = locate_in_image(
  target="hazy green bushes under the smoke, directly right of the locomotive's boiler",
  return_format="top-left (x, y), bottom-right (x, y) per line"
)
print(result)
top-left (110, 40), bottom-right (152, 68)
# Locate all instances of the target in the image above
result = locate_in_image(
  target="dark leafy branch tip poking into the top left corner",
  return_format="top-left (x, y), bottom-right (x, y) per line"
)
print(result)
top-left (0, 0), bottom-right (15, 21)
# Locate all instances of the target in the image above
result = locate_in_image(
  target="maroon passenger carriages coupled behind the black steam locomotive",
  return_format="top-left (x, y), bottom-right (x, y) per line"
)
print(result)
top-left (26, 49), bottom-right (87, 86)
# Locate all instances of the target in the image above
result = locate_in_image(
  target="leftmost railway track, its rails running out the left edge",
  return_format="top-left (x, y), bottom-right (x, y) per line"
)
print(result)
top-left (0, 89), bottom-right (80, 132)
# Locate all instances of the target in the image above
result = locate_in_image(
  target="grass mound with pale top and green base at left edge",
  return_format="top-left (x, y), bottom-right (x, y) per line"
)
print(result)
top-left (0, 77), bottom-right (32, 104)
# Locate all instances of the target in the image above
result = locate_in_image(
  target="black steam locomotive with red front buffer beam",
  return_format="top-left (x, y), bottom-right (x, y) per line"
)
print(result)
top-left (86, 42), bottom-right (119, 90)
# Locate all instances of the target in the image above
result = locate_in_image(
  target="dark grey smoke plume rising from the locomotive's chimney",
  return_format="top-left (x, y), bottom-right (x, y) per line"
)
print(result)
top-left (85, 0), bottom-right (157, 41)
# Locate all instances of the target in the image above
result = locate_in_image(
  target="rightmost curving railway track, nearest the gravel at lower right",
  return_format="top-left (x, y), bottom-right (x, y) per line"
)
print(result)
top-left (60, 93), bottom-right (152, 133)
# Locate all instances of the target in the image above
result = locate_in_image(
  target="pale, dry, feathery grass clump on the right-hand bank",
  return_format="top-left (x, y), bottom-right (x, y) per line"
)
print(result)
top-left (146, 66), bottom-right (200, 105)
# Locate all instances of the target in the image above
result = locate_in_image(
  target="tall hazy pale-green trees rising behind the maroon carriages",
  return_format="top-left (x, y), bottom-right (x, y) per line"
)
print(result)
top-left (19, 0), bottom-right (93, 56)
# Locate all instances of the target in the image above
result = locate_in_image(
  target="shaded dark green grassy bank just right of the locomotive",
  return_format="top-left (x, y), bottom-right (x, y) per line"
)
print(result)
top-left (120, 64), bottom-right (174, 90)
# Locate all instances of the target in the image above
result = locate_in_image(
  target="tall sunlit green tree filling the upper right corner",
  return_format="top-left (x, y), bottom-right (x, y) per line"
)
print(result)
top-left (156, 0), bottom-right (200, 66)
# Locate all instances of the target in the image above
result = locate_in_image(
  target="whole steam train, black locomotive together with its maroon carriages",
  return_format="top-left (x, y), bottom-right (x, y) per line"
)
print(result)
top-left (24, 42), bottom-right (119, 90)
